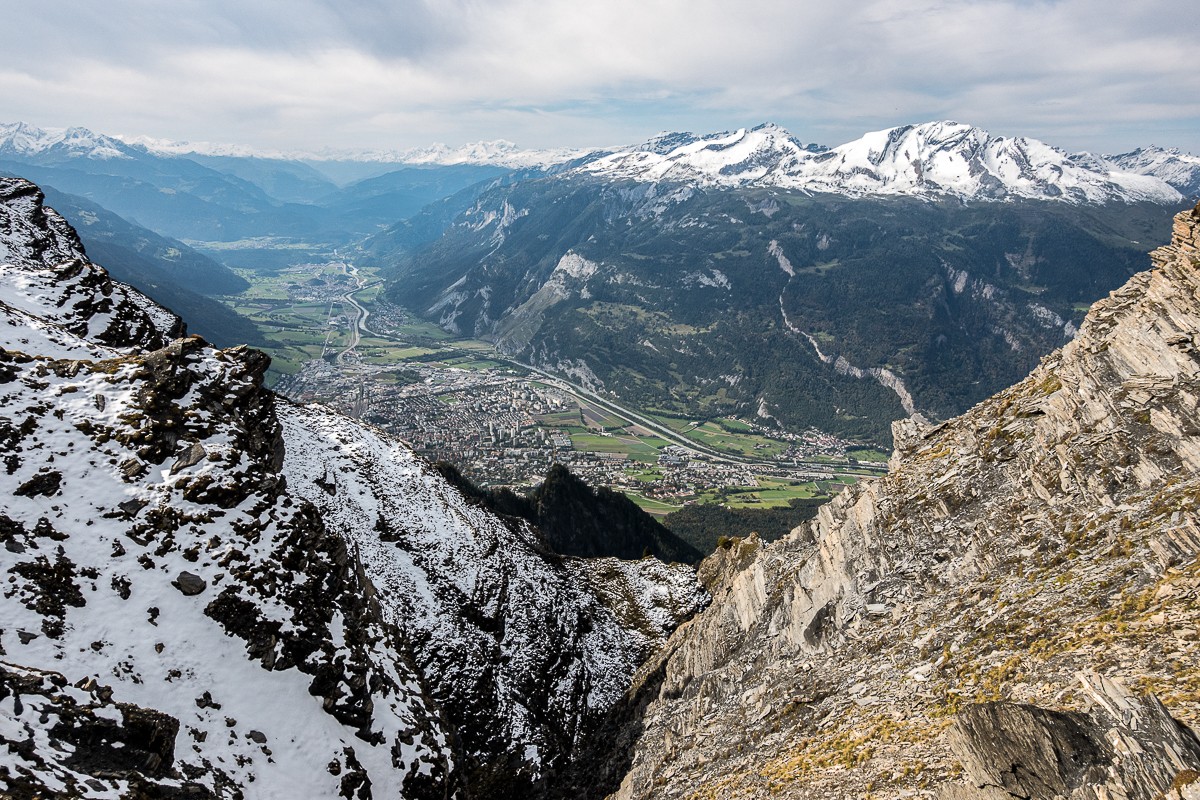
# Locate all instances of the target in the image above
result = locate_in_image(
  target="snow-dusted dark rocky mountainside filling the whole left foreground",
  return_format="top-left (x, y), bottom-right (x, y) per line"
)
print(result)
top-left (0, 179), bottom-right (703, 798)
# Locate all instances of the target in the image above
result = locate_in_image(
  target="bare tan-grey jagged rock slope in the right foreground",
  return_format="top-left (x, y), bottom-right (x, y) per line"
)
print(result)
top-left (608, 209), bottom-right (1200, 799)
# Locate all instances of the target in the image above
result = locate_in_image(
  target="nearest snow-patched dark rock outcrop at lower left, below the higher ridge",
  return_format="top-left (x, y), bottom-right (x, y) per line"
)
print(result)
top-left (0, 323), bottom-right (454, 796)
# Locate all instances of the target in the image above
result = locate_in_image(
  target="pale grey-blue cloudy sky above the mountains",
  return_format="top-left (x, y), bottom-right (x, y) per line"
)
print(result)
top-left (0, 0), bottom-right (1200, 154)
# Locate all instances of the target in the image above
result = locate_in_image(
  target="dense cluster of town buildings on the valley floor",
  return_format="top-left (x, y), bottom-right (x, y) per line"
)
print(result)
top-left (276, 359), bottom-right (859, 503)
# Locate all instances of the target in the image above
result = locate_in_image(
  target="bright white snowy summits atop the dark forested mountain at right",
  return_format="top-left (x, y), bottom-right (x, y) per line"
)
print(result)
top-left (576, 122), bottom-right (1182, 204)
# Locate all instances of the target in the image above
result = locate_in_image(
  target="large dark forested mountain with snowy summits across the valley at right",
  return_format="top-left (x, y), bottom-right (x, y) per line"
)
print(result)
top-left (368, 122), bottom-right (1200, 444)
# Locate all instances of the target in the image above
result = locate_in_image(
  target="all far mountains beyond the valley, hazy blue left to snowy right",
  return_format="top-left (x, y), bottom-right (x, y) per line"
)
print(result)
top-left (0, 121), bottom-right (1200, 444)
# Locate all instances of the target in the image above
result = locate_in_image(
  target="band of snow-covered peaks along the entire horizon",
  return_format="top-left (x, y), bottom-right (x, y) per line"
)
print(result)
top-left (7, 121), bottom-right (1200, 203)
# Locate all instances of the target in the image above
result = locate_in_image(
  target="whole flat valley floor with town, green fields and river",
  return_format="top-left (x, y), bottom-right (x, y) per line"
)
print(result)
top-left (243, 263), bottom-right (883, 513)
